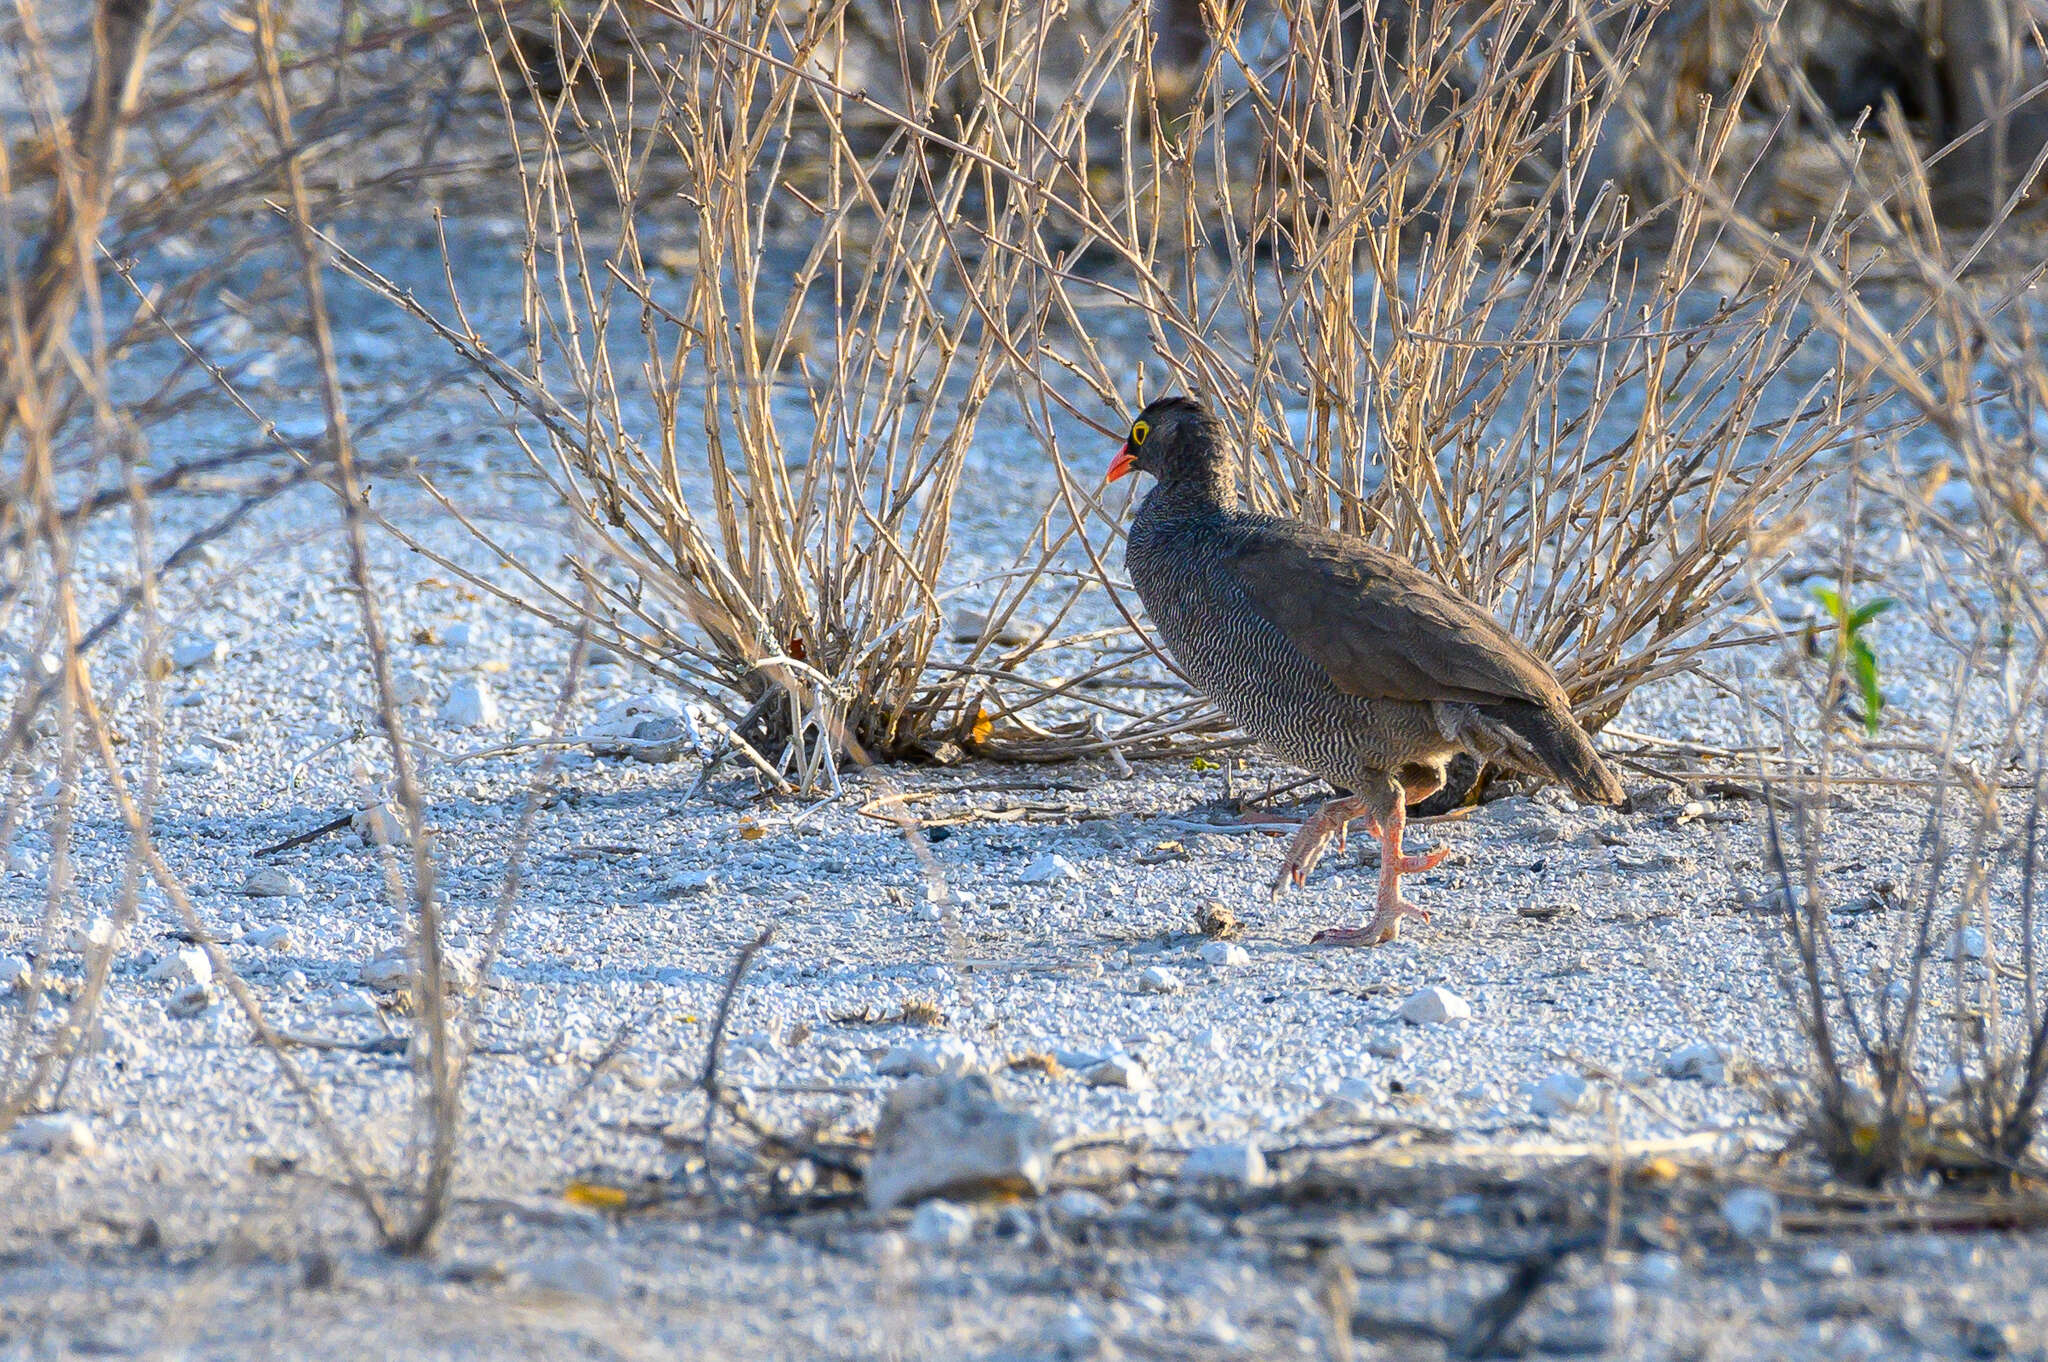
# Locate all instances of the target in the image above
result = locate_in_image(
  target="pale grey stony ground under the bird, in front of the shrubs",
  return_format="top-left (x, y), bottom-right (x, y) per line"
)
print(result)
top-left (0, 218), bottom-right (2048, 1360)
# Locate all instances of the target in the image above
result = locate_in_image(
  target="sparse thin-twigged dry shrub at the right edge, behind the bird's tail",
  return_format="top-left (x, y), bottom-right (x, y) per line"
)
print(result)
top-left (1759, 475), bottom-right (2048, 1186)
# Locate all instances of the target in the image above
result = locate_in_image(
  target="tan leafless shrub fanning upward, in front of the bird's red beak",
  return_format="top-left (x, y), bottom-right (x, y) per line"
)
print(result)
top-left (352, 4), bottom-right (1141, 784)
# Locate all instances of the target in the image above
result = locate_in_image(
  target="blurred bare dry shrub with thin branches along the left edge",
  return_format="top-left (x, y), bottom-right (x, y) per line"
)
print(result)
top-left (0, 0), bottom-right (516, 1249)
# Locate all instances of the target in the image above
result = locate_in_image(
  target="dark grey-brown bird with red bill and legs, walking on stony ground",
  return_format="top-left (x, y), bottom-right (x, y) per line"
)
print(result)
top-left (1108, 395), bottom-right (1624, 946)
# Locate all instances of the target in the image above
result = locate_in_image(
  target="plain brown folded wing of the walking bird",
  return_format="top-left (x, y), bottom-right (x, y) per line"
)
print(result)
top-left (1231, 520), bottom-right (1571, 711)
